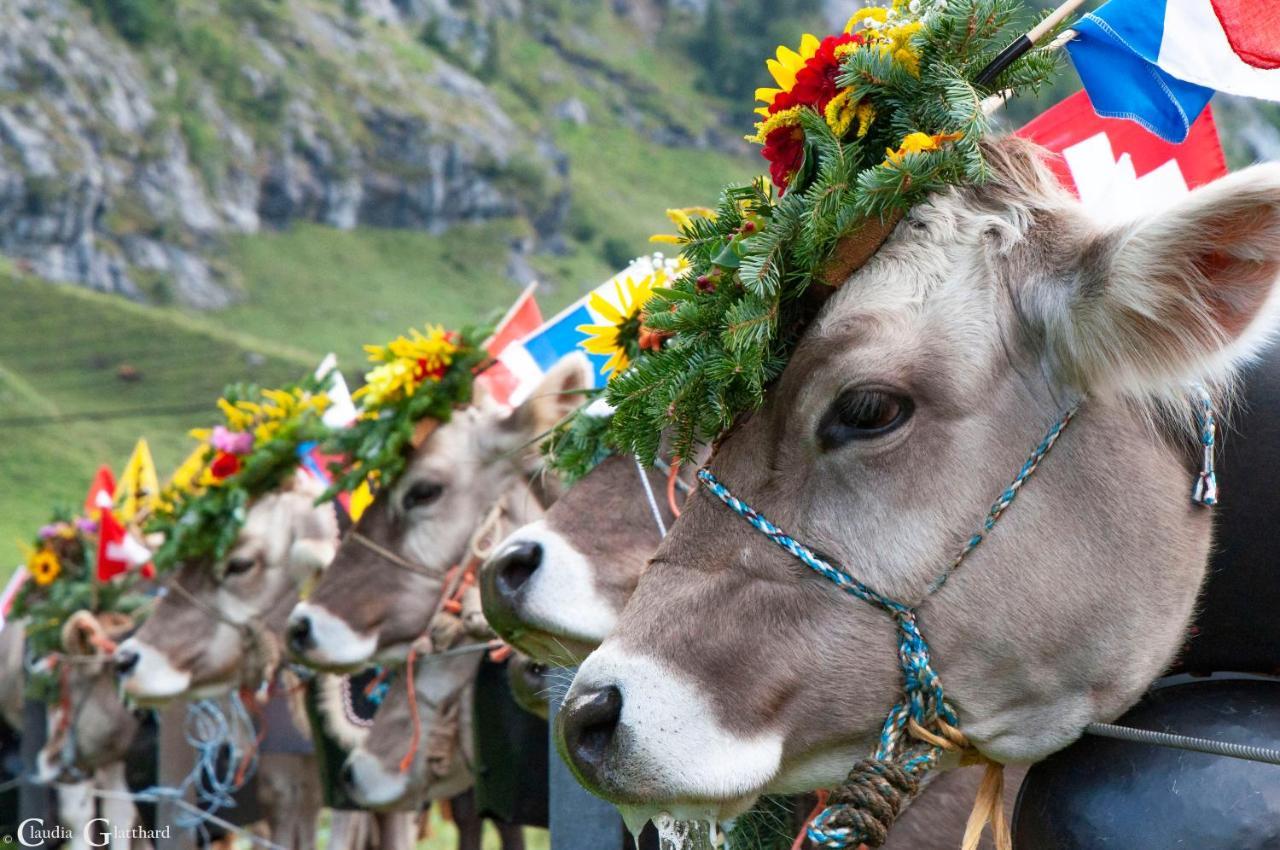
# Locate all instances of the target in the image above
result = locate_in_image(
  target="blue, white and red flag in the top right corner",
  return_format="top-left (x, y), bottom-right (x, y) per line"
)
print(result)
top-left (1068, 0), bottom-right (1280, 142)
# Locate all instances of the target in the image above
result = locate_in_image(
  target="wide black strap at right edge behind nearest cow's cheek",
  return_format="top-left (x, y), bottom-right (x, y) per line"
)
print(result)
top-left (1174, 344), bottom-right (1280, 675)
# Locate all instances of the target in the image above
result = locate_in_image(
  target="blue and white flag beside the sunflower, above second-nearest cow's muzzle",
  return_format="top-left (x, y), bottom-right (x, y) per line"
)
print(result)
top-left (498, 253), bottom-right (681, 406)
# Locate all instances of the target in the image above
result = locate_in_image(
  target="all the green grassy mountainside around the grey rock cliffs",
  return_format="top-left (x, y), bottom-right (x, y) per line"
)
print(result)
top-left (0, 0), bottom-right (773, 575)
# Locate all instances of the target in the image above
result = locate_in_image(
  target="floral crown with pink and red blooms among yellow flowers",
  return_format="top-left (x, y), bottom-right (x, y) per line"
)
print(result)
top-left (146, 379), bottom-right (329, 570)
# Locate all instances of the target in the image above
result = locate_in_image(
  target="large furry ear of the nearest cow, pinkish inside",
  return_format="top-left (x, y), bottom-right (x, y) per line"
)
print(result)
top-left (1036, 164), bottom-right (1280, 394)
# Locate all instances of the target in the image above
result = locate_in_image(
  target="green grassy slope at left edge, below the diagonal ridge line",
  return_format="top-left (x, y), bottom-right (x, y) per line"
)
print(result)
top-left (0, 271), bottom-right (315, 563)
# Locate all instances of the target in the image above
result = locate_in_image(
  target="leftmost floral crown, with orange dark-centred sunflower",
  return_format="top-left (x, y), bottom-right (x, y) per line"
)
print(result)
top-left (12, 511), bottom-right (146, 698)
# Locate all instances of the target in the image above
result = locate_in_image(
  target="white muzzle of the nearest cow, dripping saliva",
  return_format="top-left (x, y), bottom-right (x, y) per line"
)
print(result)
top-left (556, 641), bottom-right (783, 821)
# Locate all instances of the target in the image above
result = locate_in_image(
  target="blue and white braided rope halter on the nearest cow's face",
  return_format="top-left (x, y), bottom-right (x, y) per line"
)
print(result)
top-left (698, 407), bottom-right (1078, 850)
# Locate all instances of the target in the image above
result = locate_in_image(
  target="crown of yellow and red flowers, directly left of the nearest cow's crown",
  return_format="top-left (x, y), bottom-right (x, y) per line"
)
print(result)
top-left (325, 325), bottom-right (489, 497)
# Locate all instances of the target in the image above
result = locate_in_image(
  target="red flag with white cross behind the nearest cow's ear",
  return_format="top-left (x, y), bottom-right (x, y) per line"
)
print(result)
top-left (1018, 91), bottom-right (1228, 219)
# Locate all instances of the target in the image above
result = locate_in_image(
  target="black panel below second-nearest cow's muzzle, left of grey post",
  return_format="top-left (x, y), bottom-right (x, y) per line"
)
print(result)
top-left (474, 658), bottom-right (548, 827)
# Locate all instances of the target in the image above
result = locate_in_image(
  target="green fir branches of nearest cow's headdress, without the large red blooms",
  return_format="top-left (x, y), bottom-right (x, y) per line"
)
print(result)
top-left (548, 0), bottom-right (1057, 475)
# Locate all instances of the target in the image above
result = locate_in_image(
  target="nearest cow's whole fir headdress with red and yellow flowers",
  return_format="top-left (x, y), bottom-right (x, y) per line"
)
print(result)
top-left (549, 0), bottom-right (1057, 472)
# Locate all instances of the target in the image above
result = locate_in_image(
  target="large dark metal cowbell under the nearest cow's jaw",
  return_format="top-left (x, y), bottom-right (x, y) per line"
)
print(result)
top-left (1014, 678), bottom-right (1280, 850)
